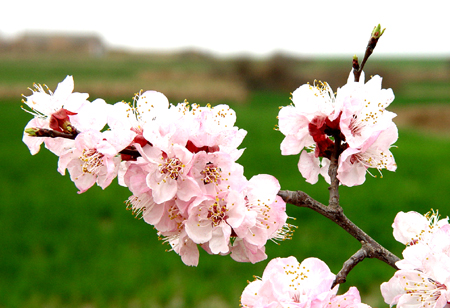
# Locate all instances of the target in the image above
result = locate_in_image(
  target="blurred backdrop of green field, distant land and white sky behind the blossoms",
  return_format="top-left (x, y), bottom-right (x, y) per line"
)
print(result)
top-left (0, 0), bottom-right (450, 308)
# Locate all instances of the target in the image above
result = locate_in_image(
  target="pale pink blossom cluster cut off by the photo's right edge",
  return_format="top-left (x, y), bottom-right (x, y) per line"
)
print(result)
top-left (381, 212), bottom-right (450, 308)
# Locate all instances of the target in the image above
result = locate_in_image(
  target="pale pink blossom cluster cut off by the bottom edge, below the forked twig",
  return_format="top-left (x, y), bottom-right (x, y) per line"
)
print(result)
top-left (241, 257), bottom-right (369, 308)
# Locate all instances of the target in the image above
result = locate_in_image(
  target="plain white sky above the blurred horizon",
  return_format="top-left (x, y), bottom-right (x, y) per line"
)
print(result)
top-left (0, 0), bottom-right (450, 57)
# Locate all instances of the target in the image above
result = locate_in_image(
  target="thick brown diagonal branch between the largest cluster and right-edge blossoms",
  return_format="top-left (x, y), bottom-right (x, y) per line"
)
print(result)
top-left (278, 190), bottom-right (400, 278)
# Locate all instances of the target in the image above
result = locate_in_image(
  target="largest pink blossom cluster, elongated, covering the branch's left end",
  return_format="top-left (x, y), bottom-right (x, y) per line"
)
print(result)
top-left (23, 76), bottom-right (290, 265)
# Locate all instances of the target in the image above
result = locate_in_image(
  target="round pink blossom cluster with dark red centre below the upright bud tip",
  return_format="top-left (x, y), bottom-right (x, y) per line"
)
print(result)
top-left (278, 73), bottom-right (398, 186)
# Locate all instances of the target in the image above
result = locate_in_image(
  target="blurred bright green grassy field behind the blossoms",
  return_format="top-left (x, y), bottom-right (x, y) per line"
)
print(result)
top-left (0, 53), bottom-right (450, 308)
